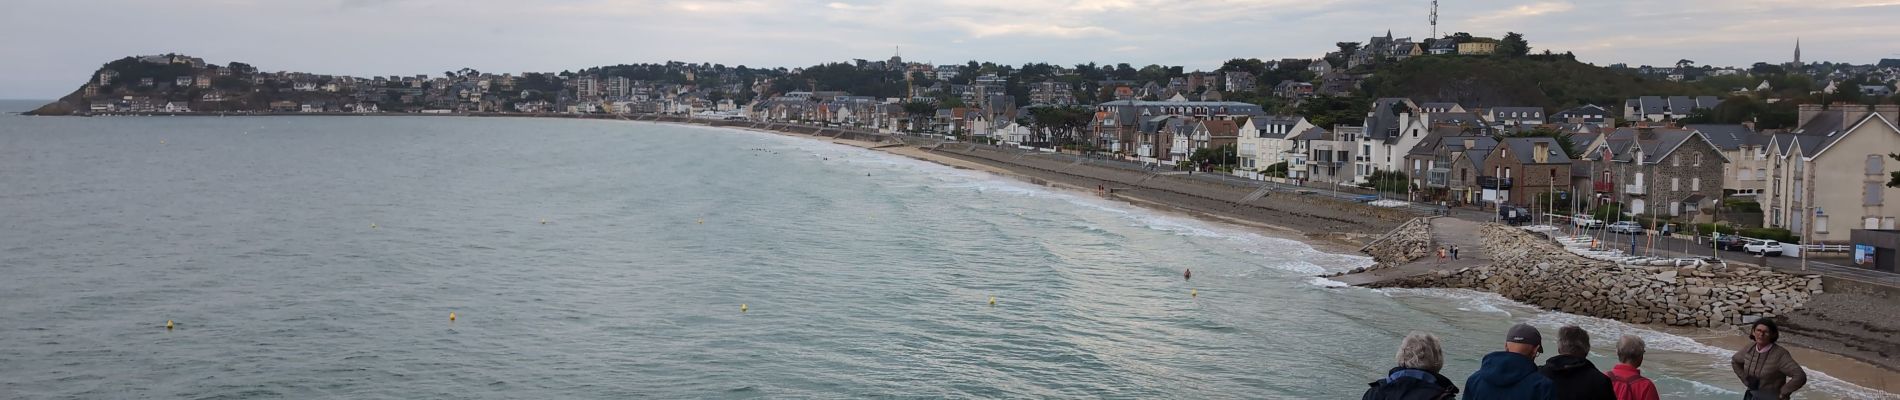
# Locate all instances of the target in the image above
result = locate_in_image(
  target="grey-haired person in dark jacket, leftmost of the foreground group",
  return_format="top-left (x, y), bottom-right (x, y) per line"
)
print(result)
top-left (1360, 332), bottom-right (1457, 400)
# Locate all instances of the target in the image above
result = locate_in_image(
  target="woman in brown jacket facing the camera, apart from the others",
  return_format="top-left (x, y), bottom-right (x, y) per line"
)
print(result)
top-left (1729, 318), bottom-right (1807, 400)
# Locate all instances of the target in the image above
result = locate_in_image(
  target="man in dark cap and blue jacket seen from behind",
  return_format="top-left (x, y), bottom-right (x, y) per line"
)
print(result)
top-left (1465, 324), bottom-right (1550, 400)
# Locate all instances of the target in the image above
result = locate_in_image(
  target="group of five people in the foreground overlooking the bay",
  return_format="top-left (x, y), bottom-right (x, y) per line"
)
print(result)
top-left (1362, 320), bottom-right (1807, 400)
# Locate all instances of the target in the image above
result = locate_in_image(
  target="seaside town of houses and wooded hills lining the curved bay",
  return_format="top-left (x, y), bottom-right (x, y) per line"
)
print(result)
top-left (36, 32), bottom-right (1900, 257)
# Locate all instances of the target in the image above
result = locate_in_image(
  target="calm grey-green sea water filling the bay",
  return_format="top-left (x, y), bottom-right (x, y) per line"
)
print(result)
top-left (0, 102), bottom-right (1887, 398)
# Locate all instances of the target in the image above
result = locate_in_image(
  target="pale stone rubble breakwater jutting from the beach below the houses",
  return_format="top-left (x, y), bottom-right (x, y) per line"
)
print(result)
top-left (1370, 224), bottom-right (1822, 326)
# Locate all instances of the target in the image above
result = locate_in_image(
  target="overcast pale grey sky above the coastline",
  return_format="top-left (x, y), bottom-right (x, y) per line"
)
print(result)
top-left (0, 0), bottom-right (1900, 99)
